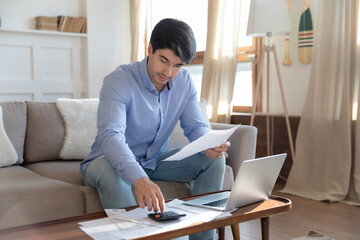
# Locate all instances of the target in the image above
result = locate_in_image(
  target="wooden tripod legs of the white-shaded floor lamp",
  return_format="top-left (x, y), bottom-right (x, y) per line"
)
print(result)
top-left (250, 45), bottom-right (295, 171)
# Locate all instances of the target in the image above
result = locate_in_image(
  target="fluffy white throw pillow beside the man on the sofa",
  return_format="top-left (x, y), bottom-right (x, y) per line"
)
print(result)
top-left (56, 98), bottom-right (99, 159)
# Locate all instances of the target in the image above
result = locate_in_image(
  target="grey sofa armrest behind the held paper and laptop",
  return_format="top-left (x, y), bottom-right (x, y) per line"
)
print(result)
top-left (211, 123), bottom-right (257, 177)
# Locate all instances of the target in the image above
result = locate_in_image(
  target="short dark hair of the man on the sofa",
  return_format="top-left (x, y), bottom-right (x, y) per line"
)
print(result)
top-left (150, 18), bottom-right (196, 64)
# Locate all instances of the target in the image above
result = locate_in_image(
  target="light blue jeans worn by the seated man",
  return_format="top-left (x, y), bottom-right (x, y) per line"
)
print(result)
top-left (83, 148), bottom-right (225, 240)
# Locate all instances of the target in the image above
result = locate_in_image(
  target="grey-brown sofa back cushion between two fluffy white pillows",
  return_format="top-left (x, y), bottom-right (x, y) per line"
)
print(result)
top-left (24, 101), bottom-right (65, 162)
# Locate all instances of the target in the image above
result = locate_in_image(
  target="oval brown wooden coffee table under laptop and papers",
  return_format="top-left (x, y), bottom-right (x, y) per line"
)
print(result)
top-left (0, 196), bottom-right (292, 240)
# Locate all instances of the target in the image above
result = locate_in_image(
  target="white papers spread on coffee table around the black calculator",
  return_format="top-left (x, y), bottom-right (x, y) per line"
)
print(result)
top-left (79, 199), bottom-right (230, 240)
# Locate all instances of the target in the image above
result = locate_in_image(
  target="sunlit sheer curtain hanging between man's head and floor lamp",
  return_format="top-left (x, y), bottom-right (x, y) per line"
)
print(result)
top-left (201, 0), bottom-right (241, 123)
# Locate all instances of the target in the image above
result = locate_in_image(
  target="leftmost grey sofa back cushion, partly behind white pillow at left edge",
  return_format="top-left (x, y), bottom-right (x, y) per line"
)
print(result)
top-left (0, 102), bottom-right (26, 164)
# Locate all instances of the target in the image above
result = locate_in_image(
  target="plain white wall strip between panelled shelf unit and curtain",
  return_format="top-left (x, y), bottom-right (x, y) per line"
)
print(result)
top-left (87, 0), bottom-right (131, 97)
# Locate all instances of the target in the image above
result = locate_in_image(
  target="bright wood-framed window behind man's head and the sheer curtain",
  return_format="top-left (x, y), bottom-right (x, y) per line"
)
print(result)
top-left (150, 0), bottom-right (261, 112)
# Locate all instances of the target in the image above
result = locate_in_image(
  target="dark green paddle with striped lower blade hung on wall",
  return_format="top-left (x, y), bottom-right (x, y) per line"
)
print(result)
top-left (298, 0), bottom-right (314, 64)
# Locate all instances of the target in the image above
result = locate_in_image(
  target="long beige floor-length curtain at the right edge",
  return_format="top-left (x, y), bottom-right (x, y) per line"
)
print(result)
top-left (283, 0), bottom-right (360, 204)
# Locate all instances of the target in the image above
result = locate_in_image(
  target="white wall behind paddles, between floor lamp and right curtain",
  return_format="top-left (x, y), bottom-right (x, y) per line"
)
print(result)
top-left (263, 0), bottom-right (317, 115)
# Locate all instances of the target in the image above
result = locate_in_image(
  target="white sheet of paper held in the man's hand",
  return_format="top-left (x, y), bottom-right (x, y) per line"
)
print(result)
top-left (163, 124), bottom-right (240, 161)
